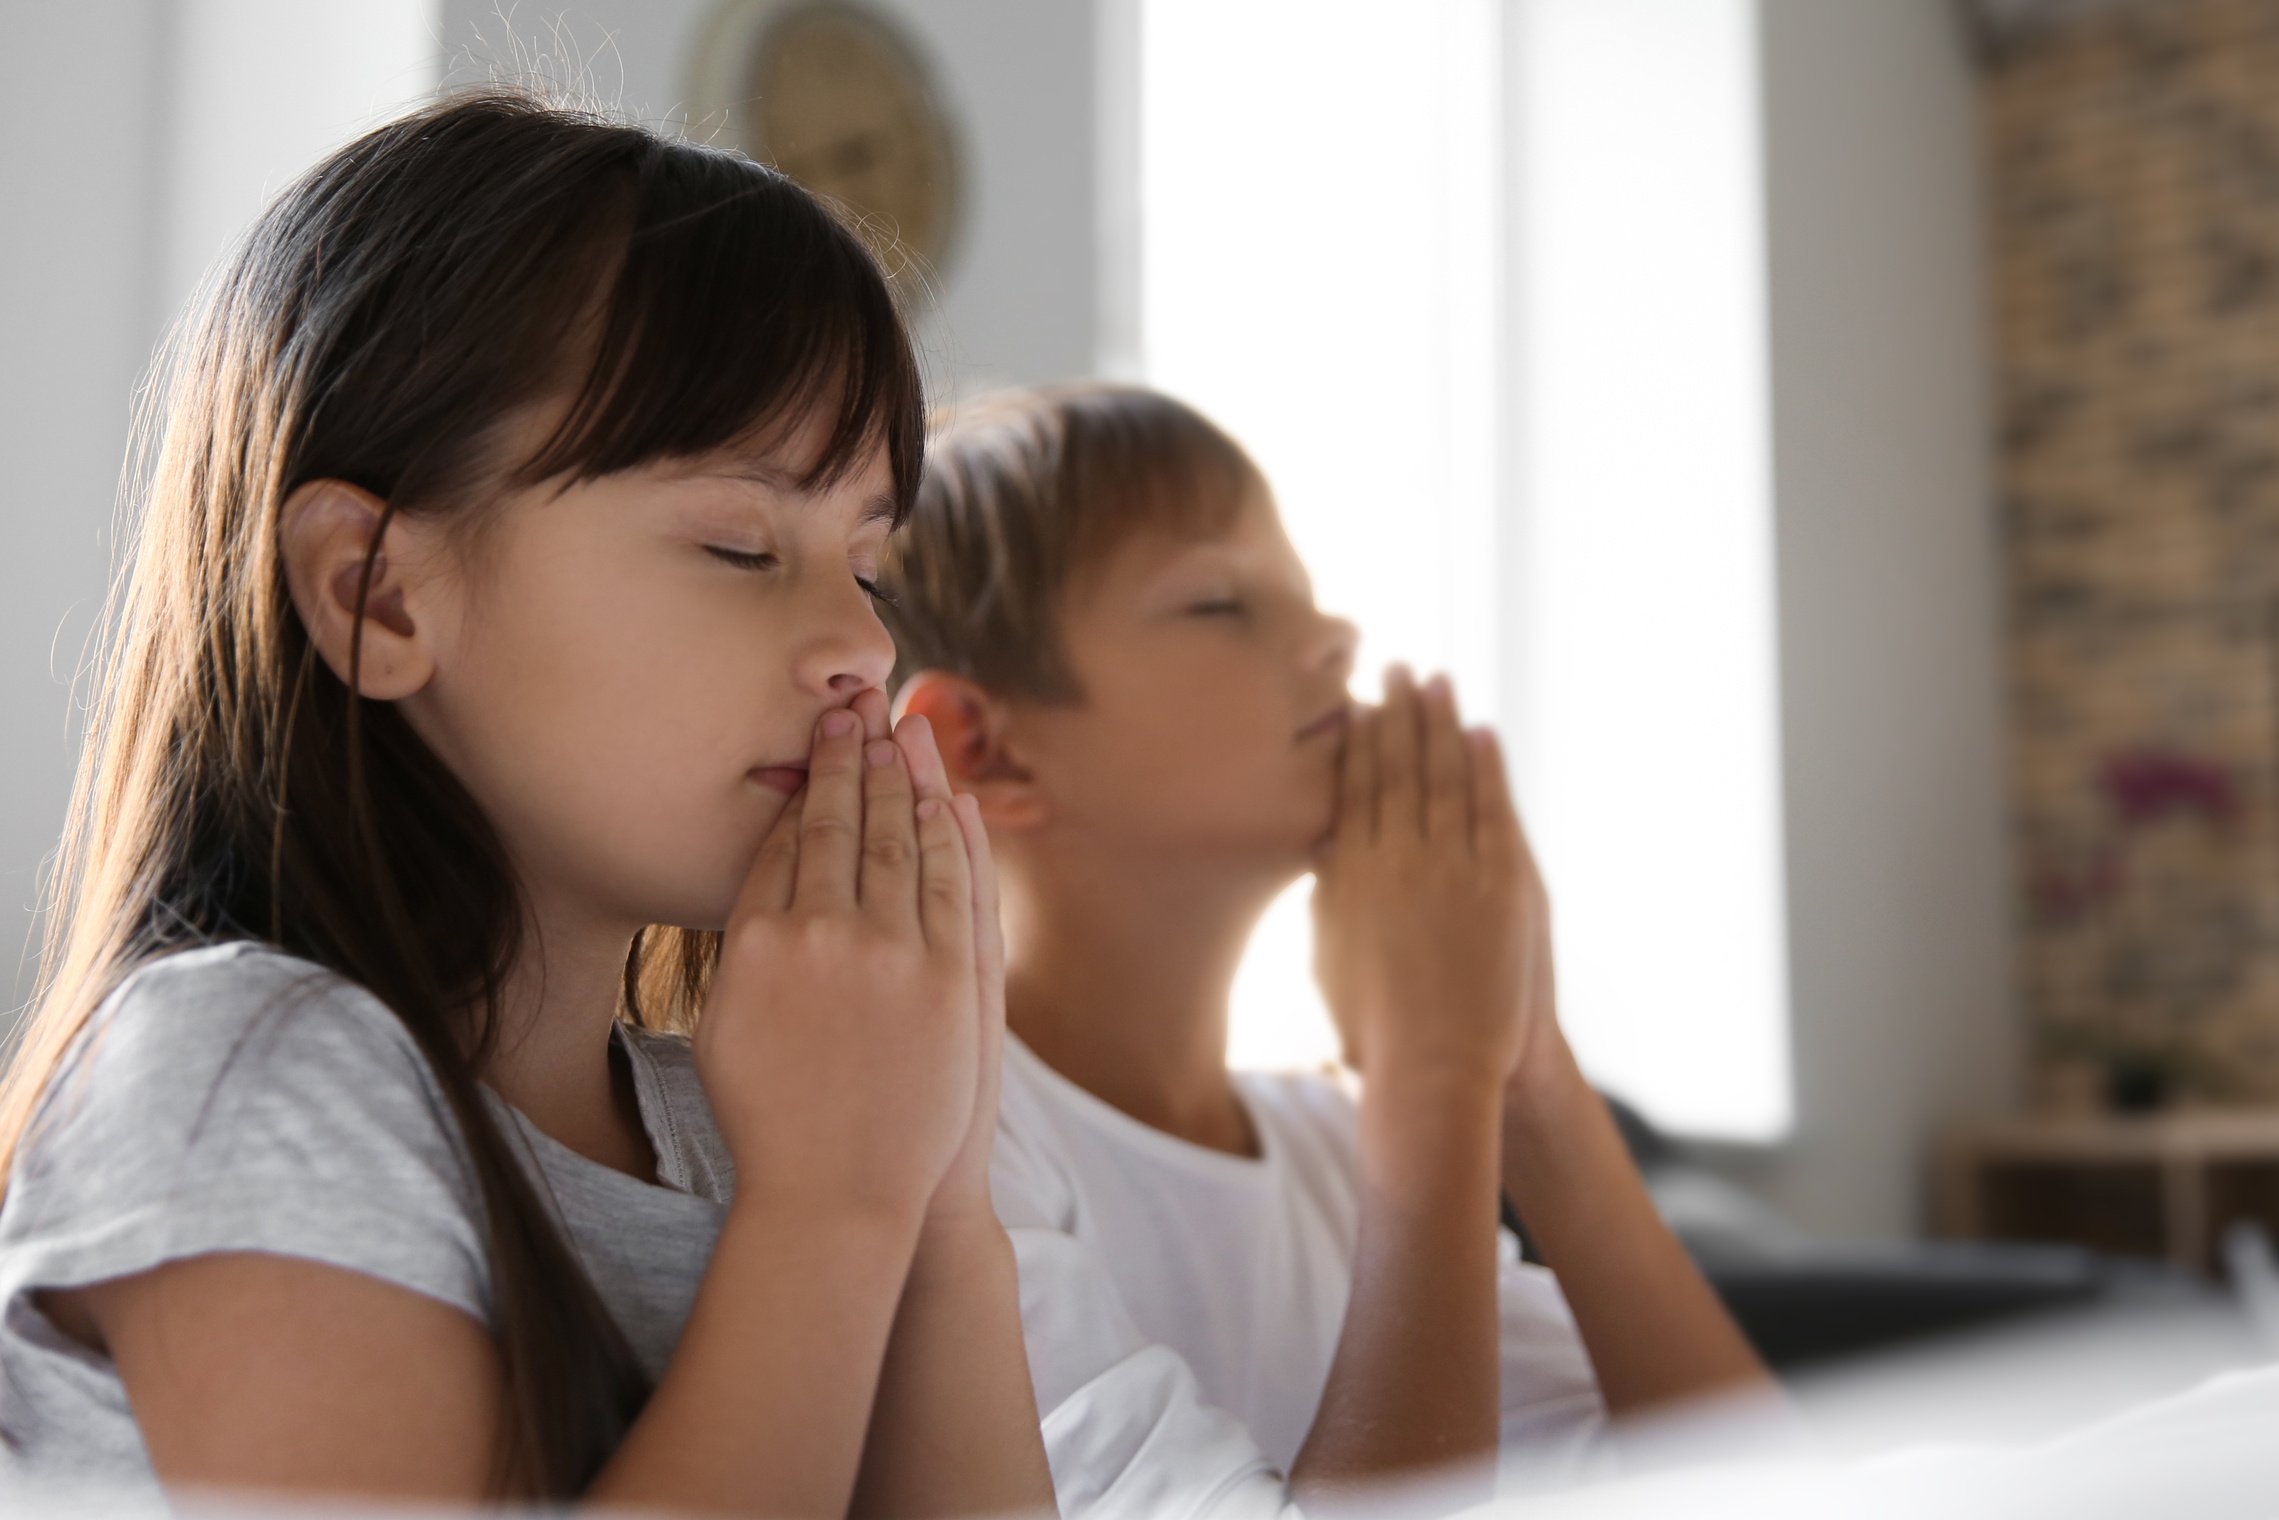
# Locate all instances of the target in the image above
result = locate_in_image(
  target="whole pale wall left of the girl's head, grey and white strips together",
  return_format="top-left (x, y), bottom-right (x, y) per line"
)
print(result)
top-left (0, 0), bottom-right (435, 1028)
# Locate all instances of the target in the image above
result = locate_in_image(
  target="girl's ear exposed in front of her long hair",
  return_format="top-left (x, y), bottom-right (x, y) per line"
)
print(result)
top-left (278, 481), bottom-right (435, 702)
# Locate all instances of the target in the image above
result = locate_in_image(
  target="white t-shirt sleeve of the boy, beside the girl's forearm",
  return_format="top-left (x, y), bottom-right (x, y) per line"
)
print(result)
top-left (989, 1093), bottom-right (1297, 1520)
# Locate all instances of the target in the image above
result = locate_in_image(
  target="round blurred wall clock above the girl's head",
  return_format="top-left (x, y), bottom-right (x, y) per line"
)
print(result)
top-left (691, 0), bottom-right (962, 280)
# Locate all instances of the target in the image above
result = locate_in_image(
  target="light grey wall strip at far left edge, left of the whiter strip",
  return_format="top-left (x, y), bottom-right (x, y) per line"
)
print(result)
top-left (0, 0), bottom-right (166, 1030)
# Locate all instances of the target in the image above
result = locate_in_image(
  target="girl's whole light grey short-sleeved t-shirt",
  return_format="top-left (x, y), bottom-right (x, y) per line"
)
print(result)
top-left (0, 941), bottom-right (734, 1495)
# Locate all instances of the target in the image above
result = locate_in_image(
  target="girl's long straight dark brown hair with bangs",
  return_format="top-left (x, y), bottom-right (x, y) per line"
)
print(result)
top-left (0, 89), bottom-right (925, 1497)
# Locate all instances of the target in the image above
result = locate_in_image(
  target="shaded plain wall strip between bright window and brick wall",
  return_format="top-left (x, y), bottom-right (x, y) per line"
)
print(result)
top-left (1746, 0), bottom-right (2019, 1235)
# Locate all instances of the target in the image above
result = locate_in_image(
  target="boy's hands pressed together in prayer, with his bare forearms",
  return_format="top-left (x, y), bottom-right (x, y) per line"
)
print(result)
top-left (1313, 665), bottom-right (1766, 1465)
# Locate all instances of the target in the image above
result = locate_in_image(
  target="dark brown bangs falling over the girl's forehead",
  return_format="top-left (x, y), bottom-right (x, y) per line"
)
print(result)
top-left (515, 144), bottom-right (925, 524)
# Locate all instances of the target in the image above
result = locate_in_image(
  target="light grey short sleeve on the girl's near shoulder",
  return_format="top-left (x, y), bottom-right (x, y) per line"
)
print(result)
top-left (0, 946), bottom-right (488, 1317)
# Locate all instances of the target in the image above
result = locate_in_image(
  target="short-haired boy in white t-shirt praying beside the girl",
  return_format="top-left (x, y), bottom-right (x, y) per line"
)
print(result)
top-left (882, 385), bottom-right (1766, 1515)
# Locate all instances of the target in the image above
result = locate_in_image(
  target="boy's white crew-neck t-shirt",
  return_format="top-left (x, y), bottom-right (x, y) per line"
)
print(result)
top-left (991, 1035), bottom-right (1607, 1515)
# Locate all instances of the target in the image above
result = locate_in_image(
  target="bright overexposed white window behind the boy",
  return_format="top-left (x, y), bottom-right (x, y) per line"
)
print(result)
top-left (1137, 0), bottom-right (1791, 1139)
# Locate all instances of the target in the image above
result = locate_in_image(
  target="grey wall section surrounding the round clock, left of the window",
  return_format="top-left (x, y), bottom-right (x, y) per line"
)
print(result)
top-left (442, 0), bottom-right (1101, 397)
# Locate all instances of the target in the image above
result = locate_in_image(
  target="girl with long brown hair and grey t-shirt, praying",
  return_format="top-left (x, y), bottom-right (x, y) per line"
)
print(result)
top-left (0, 91), bottom-right (1051, 1513)
